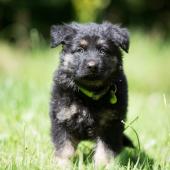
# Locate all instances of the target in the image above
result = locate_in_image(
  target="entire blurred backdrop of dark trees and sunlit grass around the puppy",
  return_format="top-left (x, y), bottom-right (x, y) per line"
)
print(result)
top-left (0, 0), bottom-right (170, 170)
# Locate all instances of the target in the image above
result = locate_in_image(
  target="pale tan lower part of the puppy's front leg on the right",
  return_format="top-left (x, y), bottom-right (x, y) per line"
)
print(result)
top-left (94, 138), bottom-right (114, 168)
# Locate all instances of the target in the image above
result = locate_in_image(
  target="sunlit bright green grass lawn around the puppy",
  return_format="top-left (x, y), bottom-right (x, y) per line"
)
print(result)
top-left (0, 31), bottom-right (170, 170)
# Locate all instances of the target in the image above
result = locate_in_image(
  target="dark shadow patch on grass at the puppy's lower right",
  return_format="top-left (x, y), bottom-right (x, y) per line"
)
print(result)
top-left (118, 148), bottom-right (154, 170)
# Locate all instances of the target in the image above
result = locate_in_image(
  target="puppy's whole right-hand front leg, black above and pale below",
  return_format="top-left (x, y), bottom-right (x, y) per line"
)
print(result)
top-left (94, 121), bottom-right (124, 166)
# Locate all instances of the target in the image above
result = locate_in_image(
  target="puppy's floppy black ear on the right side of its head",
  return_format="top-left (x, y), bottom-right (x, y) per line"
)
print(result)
top-left (107, 25), bottom-right (130, 53)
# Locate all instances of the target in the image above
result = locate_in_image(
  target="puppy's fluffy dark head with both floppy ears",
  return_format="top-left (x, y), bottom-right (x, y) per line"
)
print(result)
top-left (51, 23), bottom-right (129, 87)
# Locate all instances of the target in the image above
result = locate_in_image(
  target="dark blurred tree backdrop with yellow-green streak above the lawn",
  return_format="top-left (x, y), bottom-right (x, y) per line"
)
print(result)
top-left (0, 0), bottom-right (170, 45)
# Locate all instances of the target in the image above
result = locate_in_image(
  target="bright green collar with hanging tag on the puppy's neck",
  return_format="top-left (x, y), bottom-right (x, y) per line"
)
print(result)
top-left (79, 86), bottom-right (117, 104)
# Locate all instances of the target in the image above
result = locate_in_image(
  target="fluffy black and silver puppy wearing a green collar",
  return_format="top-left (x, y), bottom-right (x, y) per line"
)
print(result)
top-left (50, 22), bottom-right (132, 166)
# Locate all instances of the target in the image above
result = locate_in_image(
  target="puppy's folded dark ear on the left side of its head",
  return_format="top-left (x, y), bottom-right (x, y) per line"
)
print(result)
top-left (50, 25), bottom-right (75, 48)
